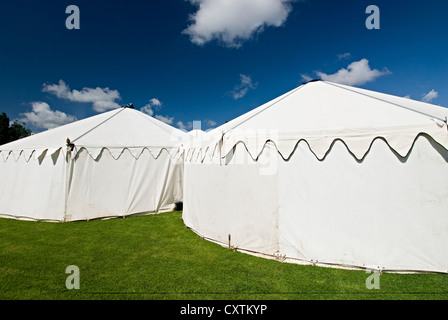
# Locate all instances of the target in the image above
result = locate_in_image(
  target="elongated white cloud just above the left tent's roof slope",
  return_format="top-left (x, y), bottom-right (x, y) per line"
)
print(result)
top-left (42, 80), bottom-right (121, 112)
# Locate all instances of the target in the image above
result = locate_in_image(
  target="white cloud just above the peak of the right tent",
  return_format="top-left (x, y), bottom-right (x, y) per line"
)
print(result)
top-left (302, 59), bottom-right (391, 86)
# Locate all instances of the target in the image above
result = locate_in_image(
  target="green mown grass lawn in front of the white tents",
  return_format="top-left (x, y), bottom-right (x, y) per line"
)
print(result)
top-left (0, 212), bottom-right (448, 300)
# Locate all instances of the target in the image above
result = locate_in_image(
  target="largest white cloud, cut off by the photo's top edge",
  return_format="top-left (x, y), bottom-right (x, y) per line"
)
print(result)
top-left (183, 0), bottom-right (293, 48)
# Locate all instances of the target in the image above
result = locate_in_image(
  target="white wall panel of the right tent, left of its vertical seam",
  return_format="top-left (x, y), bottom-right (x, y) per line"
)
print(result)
top-left (183, 145), bottom-right (278, 253)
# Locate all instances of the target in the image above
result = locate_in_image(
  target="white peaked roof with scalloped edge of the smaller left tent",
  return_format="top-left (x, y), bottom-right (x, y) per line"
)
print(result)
top-left (0, 108), bottom-right (186, 160)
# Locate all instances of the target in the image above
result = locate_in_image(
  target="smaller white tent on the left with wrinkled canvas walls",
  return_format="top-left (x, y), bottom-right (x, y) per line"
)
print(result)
top-left (0, 107), bottom-right (186, 221)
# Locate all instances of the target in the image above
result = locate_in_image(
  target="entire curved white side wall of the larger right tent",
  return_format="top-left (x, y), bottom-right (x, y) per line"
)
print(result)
top-left (184, 136), bottom-right (448, 272)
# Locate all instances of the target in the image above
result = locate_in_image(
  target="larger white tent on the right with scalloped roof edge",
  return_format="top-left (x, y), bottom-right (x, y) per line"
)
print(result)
top-left (183, 81), bottom-right (448, 272)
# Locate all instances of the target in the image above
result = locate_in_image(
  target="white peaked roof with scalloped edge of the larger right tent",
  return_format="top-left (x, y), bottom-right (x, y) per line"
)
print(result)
top-left (191, 81), bottom-right (448, 159)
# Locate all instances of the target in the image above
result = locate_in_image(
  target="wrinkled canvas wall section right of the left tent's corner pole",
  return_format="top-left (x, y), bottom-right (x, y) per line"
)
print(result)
top-left (66, 149), bottom-right (183, 221)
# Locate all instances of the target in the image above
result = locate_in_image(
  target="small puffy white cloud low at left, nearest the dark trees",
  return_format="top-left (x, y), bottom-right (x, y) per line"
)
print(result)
top-left (19, 101), bottom-right (77, 129)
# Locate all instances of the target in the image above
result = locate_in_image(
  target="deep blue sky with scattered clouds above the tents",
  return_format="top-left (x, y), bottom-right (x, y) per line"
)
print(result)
top-left (0, 0), bottom-right (448, 132)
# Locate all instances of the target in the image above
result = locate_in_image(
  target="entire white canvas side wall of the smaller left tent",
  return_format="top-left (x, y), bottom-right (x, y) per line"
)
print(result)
top-left (0, 149), bottom-right (183, 222)
